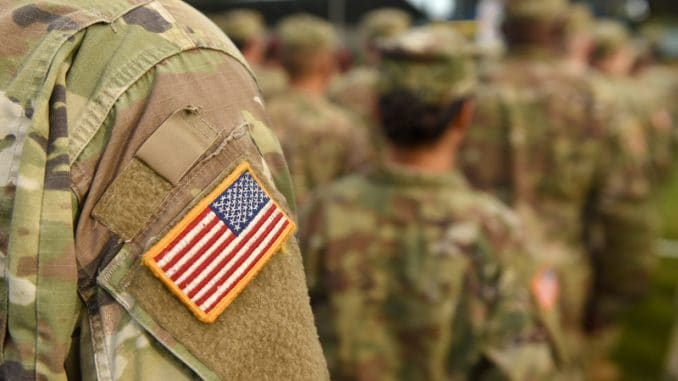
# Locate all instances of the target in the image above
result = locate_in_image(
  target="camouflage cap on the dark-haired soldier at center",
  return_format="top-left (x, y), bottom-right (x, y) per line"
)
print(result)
top-left (378, 26), bottom-right (478, 106)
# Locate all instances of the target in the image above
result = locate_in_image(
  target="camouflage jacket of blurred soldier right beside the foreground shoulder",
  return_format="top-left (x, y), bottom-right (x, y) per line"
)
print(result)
top-left (268, 89), bottom-right (367, 205)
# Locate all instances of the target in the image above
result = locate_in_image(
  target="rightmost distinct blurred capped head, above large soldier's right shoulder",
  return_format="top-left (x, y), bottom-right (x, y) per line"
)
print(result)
top-left (591, 20), bottom-right (635, 75)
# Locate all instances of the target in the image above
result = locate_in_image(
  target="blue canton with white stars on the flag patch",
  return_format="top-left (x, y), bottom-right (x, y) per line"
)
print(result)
top-left (210, 172), bottom-right (269, 235)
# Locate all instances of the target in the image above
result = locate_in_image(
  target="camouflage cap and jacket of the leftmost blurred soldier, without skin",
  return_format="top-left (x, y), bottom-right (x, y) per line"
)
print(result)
top-left (210, 9), bottom-right (288, 99)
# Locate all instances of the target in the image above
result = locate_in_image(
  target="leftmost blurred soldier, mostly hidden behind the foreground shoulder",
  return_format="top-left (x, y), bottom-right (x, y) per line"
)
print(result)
top-left (210, 9), bottom-right (287, 99)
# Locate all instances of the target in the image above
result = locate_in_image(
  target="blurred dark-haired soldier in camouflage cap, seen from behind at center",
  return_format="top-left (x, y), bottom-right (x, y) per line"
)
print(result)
top-left (301, 28), bottom-right (556, 381)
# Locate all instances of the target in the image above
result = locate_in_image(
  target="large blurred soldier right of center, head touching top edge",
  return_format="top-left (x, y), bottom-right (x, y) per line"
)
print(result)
top-left (460, 0), bottom-right (654, 374)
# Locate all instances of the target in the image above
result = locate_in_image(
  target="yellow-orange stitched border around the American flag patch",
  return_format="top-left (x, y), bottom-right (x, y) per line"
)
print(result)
top-left (142, 161), bottom-right (296, 323)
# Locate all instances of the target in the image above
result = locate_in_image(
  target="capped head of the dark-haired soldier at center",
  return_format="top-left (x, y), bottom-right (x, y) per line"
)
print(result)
top-left (378, 26), bottom-right (477, 155)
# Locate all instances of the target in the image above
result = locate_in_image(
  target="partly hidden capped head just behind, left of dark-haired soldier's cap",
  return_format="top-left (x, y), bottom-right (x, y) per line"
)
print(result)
top-left (359, 8), bottom-right (412, 63)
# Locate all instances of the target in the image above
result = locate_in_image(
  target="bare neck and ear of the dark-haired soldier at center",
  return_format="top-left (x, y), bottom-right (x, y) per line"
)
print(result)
top-left (386, 100), bottom-right (475, 174)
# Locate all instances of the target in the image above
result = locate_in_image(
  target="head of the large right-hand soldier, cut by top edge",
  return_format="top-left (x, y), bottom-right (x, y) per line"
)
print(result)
top-left (502, 0), bottom-right (570, 50)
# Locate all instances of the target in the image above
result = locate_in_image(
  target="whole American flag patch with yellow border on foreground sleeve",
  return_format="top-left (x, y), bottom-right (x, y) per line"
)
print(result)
top-left (143, 162), bottom-right (295, 323)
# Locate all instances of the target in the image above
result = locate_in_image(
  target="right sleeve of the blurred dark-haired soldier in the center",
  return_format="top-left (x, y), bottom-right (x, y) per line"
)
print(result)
top-left (464, 203), bottom-right (556, 380)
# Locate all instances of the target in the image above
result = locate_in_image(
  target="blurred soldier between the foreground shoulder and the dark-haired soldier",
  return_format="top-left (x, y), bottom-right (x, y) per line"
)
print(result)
top-left (269, 15), bottom-right (367, 208)
